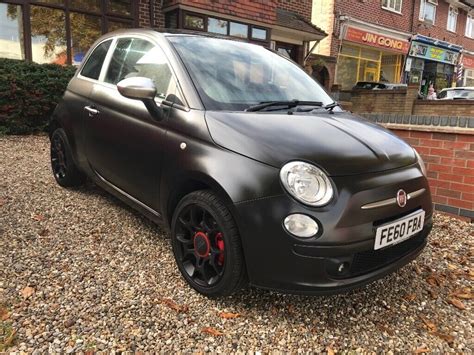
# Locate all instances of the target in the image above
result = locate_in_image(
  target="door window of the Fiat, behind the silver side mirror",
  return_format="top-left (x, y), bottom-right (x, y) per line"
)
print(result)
top-left (105, 38), bottom-right (176, 99)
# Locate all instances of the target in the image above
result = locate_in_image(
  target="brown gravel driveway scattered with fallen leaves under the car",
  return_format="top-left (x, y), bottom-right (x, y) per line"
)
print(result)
top-left (0, 136), bottom-right (474, 353)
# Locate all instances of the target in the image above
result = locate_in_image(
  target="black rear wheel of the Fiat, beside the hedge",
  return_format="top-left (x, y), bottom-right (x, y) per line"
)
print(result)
top-left (51, 128), bottom-right (85, 187)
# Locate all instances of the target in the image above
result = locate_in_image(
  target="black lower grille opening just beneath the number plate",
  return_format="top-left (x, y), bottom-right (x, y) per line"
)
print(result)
top-left (350, 232), bottom-right (425, 277)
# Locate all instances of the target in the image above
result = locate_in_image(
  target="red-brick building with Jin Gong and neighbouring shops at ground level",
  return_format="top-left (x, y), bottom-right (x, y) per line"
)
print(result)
top-left (311, 0), bottom-right (474, 93)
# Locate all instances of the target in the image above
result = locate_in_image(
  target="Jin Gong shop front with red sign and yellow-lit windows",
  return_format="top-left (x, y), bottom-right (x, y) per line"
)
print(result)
top-left (335, 25), bottom-right (410, 90)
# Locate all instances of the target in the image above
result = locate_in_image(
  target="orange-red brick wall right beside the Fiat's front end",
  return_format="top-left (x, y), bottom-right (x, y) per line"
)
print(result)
top-left (393, 129), bottom-right (474, 220)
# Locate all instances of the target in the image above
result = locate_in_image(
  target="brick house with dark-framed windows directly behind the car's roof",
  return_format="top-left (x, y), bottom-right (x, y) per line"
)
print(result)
top-left (0, 0), bottom-right (326, 64)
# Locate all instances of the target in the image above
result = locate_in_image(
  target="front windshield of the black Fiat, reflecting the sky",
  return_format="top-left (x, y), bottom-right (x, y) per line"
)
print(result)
top-left (168, 36), bottom-right (333, 111)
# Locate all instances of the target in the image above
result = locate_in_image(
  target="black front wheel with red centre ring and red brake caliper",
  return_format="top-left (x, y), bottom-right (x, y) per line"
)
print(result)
top-left (171, 190), bottom-right (247, 297)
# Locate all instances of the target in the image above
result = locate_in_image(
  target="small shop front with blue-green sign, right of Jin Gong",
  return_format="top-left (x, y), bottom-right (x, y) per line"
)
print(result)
top-left (405, 35), bottom-right (462, 95)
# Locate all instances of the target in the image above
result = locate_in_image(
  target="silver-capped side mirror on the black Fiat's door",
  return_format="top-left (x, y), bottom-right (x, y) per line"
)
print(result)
top-left (117, 76), bottom-right (163, 120)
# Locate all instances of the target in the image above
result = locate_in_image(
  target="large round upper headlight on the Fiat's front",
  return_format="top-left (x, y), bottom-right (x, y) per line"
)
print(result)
top-left (280, 161), bottom-right (334, 206)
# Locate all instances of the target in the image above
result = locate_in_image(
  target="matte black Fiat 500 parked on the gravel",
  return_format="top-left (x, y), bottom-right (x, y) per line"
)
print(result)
top-left (50, 30), bottom-right (432, 297)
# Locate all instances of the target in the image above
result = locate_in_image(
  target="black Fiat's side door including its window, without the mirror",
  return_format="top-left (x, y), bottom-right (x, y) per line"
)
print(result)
top-left (85, 37), bottom-right (178, 212)
